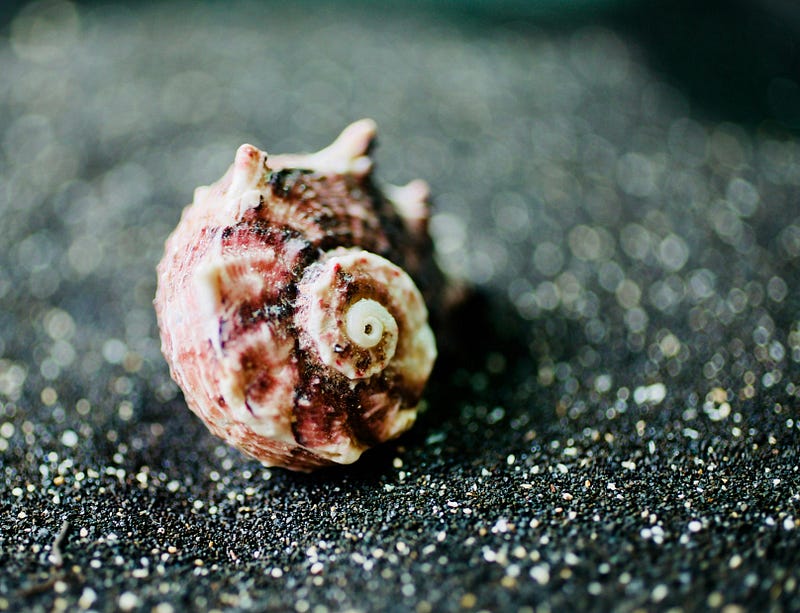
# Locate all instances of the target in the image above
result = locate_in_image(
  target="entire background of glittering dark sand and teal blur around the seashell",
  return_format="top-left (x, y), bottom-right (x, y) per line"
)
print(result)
top-left (0, 0), bottom-right (800, 613)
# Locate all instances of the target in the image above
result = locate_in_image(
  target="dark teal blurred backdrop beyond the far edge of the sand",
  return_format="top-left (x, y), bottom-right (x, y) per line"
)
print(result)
top-left (0, 0), bottom-right (800, 131)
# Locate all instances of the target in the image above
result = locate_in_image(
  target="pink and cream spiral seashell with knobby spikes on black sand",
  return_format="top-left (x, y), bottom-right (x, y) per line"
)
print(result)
top-left (155, 120), bottom-right (440, 471)
